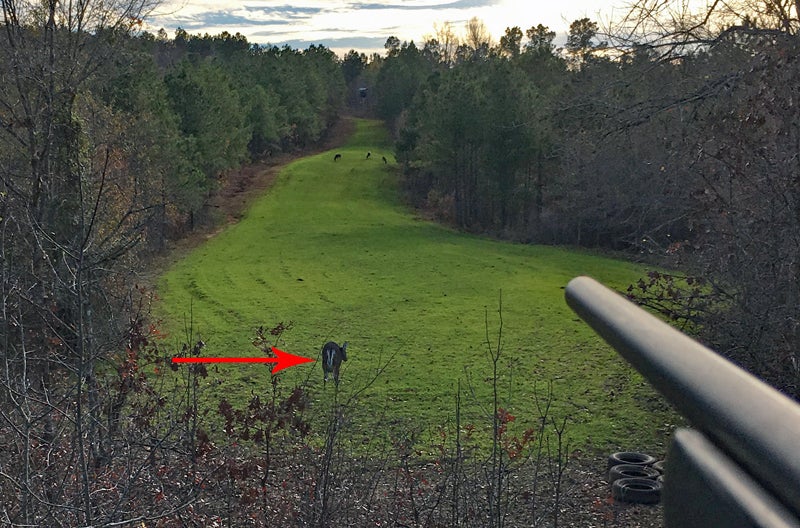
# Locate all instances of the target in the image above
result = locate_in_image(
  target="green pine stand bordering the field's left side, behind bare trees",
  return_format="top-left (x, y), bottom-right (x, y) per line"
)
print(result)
top-left (106, 30), bottom-right (345, 240)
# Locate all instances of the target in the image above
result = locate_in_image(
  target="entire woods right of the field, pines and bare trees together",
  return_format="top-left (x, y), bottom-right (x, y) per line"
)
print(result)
top-left (356, 13), bottom-right (800, 397)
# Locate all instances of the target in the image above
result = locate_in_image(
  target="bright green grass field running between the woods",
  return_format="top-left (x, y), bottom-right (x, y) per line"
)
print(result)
top-left (157, 121), bottom-right (675, 450)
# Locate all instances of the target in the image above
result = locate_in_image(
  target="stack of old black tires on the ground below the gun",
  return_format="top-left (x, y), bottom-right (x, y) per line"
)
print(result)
top-left (608, 451), bottom-right (664, 504)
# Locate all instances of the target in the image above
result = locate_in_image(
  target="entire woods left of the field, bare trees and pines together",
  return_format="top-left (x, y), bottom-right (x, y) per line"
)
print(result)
top-left (0, 5), bottom-right (345, 526)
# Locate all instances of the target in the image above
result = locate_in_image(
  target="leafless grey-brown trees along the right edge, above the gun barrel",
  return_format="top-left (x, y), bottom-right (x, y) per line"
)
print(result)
top-left (614, 0), bottom-right (800, 397)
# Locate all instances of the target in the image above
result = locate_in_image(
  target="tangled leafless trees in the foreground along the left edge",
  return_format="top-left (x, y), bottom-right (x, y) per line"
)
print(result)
top-left (0, 0), bottom-right (163, 525)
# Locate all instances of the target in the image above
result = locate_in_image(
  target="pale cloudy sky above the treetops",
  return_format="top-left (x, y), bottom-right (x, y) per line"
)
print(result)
top-left (146, 0), bottom-right (627, 57)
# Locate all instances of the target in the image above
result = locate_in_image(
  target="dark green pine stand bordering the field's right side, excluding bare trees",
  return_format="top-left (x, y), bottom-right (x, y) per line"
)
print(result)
top-left (356, 19), bottom-right (700, 245)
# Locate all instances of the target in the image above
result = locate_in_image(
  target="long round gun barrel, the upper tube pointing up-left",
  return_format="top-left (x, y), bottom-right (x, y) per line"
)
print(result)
top-left (566, 277), bottom-right (800, 514)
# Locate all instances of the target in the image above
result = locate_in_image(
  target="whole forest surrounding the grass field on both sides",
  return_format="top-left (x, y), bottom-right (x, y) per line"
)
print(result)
top-left (0, 0), bottom-right (800, 526)
